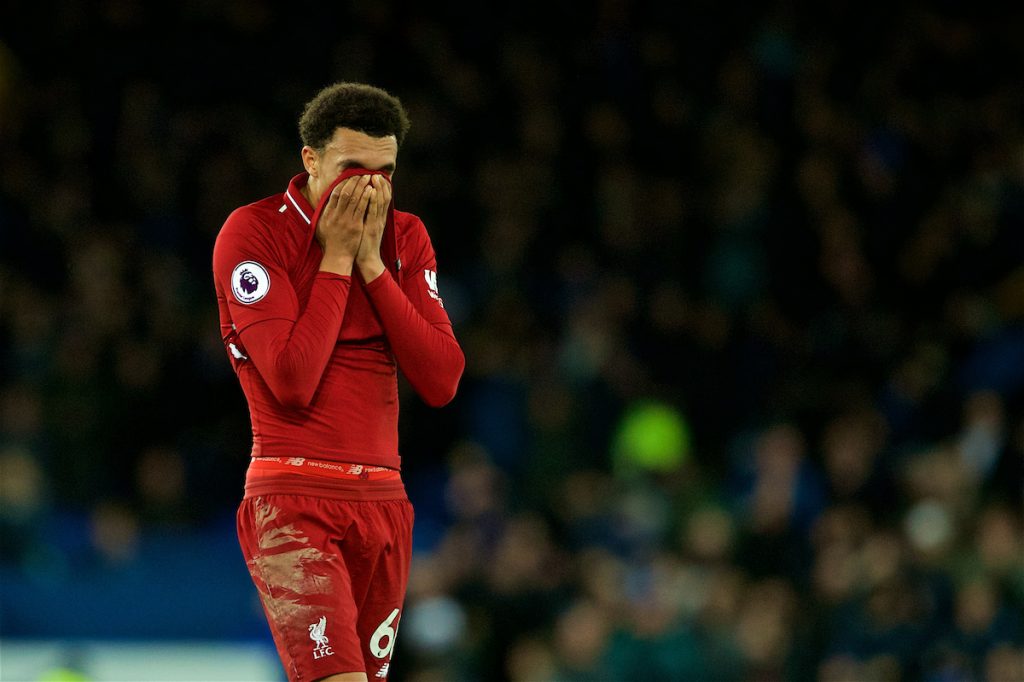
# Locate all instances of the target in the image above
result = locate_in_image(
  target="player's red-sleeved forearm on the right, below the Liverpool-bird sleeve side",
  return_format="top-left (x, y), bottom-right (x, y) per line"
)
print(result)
top-left (367, 272), bottom-right (466, 408)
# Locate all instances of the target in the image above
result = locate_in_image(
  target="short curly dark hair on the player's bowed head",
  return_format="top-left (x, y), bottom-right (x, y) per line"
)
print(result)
top-left (299, 82), bottom-right (409, 151)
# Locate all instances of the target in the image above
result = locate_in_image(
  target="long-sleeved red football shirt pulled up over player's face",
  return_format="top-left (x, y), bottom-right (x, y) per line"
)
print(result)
top-left (213, 170), bottom-right (465, 469)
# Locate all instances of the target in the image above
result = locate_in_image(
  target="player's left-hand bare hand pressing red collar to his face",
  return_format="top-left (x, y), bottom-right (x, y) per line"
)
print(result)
top-left (316, 175), bottom-right (377, 274)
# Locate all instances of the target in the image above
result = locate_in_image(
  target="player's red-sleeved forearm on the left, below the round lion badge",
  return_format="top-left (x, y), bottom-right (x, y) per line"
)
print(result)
top-left (242, 273), bottom-right (351, 409)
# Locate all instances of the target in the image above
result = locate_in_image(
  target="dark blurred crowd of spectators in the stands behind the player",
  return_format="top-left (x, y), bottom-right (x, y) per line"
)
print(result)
top-left (0, 0), bottom-right (1024, 682)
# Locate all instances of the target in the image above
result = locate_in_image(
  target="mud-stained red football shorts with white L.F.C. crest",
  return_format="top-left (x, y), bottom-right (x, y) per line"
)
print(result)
top-left (238, 495), bottom-right (413, 682)
